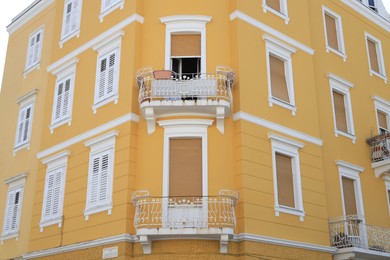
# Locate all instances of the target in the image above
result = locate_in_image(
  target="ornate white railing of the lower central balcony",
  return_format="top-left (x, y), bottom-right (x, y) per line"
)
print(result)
top-left (132, 190), bottom-right (239, 229)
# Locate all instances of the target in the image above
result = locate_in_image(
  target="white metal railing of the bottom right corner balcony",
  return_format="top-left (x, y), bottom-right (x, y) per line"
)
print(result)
top-left (329, 215), bottom-right (390, 253)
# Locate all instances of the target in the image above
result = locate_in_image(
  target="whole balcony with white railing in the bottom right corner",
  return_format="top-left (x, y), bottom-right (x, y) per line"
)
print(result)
top-left (329, 215), bottom-right (390, 260)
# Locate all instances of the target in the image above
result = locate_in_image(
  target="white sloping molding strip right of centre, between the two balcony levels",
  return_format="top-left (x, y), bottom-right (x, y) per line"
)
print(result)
top-left (233, 111), bottom-right (323, 146)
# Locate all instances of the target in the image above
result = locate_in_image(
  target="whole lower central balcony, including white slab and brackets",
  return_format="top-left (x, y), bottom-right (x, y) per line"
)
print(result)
top-left (132, 190), bottom-right (239, 254)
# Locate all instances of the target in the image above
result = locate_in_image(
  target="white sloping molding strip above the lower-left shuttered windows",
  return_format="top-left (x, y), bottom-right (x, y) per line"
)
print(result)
top-left (37, 113), bottom-right (139, 159)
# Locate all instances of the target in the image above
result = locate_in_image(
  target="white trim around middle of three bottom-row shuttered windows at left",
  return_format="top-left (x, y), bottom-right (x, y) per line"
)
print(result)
top-left (39, 150), bottom-right (70, 232)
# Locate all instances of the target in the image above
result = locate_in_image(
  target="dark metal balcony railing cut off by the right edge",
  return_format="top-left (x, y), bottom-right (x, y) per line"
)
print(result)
top-left (367, 132), bottom-right (390, 163)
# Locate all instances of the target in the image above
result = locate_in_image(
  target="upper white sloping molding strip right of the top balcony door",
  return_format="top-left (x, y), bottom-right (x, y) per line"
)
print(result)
top-left (230, 10), bottom-right (314, 55)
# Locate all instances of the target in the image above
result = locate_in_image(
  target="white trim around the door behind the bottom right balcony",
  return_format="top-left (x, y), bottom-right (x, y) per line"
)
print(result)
top-left (335, 160), bottom-right (364, 218)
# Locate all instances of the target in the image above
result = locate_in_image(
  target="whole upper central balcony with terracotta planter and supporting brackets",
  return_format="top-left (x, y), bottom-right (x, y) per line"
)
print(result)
top-left (136, 66), bottom-right (234, 134)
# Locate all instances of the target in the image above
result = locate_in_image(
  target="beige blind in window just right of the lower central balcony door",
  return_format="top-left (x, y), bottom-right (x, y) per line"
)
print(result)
top-left (275, 153), bottom-right (295, 208)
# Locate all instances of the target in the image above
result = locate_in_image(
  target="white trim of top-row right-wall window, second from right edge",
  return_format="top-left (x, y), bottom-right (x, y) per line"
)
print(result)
top-left (322, 6), bottom-right (347, 62)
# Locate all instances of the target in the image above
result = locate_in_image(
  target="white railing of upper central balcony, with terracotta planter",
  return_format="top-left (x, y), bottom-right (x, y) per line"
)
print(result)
top-left (136, 66), bottom-right (234, 104)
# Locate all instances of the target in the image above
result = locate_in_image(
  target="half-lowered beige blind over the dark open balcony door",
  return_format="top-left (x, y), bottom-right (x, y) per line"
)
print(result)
top-left (171, 34), bottom-right (200, 57)
